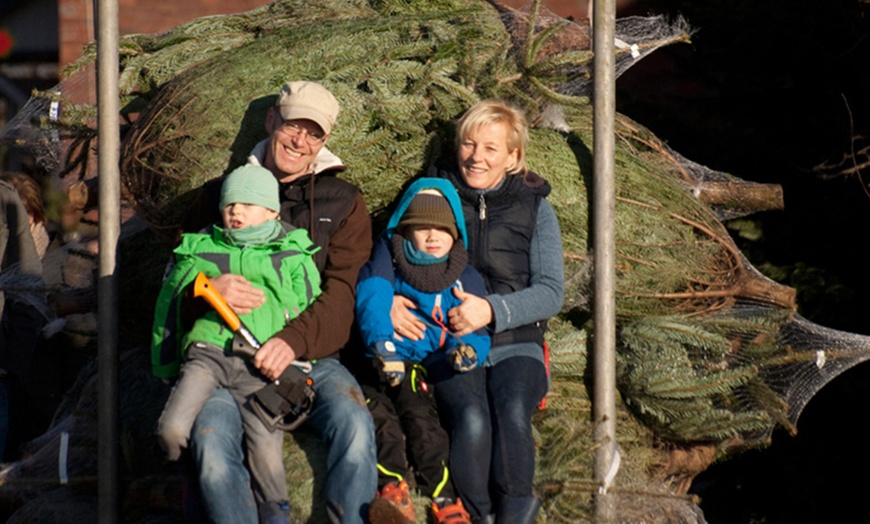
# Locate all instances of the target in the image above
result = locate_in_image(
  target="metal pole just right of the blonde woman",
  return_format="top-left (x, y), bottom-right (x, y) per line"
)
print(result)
top-left (592, 0), bottom-right (618, 523)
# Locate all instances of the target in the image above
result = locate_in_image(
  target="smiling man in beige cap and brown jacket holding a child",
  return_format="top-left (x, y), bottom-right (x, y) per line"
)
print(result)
top-left (184, 81), bottom-right (377, 524)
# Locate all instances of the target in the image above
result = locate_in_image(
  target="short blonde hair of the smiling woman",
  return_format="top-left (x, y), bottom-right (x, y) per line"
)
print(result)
top-left (456, 100), bottom-right (529, 175)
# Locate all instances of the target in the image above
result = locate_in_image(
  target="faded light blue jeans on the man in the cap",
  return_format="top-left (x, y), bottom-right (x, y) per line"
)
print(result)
top-left (191, 358), bottom-right (377, 523)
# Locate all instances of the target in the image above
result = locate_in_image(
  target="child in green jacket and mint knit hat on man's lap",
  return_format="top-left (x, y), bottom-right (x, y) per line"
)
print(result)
top-left (152, 165), bottom-right (320, 521)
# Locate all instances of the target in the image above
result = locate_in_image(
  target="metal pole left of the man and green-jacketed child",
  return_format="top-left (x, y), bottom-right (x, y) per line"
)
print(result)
top-left (96, 0), bottom-right (121, 524)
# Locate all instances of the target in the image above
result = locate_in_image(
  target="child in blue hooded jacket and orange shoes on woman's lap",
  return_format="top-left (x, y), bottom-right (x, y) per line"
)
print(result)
top-left (356, 178), bottom-right (490, 522)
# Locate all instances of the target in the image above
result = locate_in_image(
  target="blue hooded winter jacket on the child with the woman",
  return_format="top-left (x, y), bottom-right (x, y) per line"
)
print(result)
top-left (356, 178), bottom-right (490, 365)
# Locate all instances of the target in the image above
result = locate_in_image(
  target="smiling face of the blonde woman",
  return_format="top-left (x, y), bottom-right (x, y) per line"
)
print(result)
top-left (457, 122), bottom-right (518, 189)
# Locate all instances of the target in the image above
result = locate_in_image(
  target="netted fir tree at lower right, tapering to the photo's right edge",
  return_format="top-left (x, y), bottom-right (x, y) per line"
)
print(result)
top-left (620, 300), bottom-right (870, 447)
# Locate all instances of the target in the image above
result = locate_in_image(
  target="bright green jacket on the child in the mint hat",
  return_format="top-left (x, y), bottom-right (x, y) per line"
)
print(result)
top-left (151, 223), bottom-right (321, 378)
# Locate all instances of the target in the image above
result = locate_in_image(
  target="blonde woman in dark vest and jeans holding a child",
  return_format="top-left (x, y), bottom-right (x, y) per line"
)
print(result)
top-left (391, 100), bottom-right (564, 524)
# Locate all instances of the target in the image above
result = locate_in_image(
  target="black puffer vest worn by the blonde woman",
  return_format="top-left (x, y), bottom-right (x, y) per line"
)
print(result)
top-left (429, 162), bottom-right (550, 346)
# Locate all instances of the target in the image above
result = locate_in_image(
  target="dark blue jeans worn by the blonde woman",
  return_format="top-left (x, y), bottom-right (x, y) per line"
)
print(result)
top-left (435, 356), bottom-right (547, 518)
